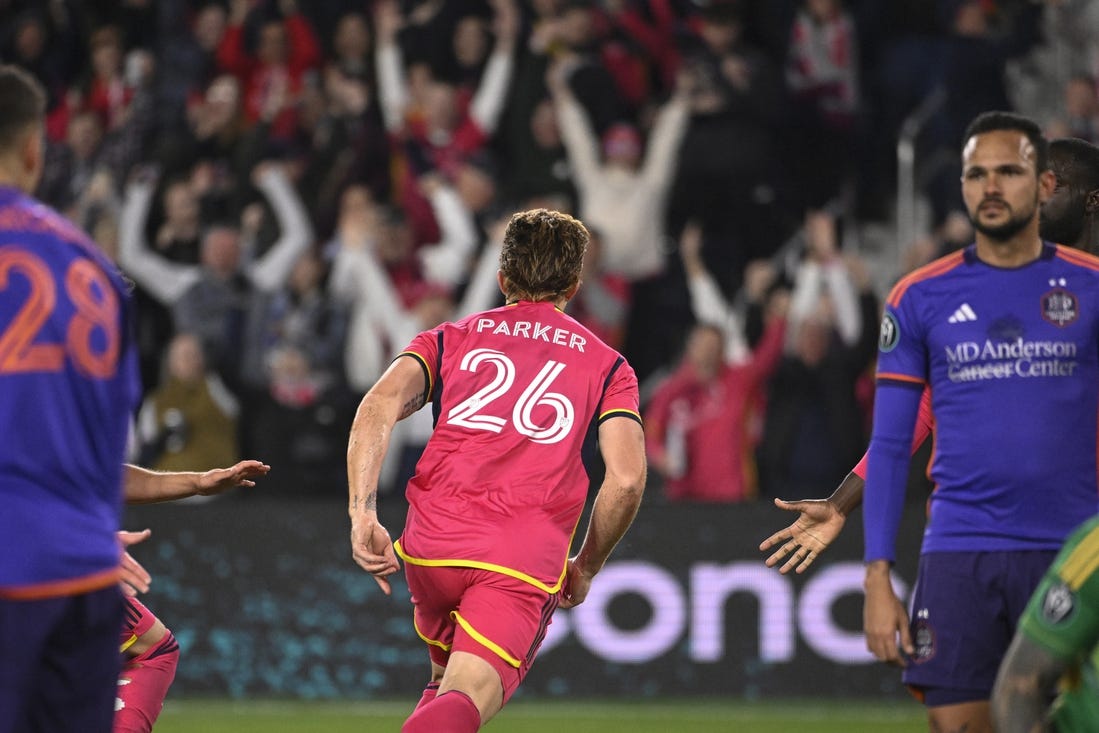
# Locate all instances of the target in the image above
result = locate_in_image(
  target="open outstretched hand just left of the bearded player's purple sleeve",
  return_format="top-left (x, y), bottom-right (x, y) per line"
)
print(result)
top-left (759, 471), bottom-right (866, 574)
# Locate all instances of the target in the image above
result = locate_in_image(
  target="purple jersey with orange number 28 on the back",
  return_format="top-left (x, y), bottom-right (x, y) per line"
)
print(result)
top-left (0, 188), bottom-right (140, 599)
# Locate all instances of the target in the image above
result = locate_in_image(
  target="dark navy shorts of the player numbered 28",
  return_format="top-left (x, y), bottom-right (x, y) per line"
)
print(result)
top-left (0, 585), bottom-right (122, 733)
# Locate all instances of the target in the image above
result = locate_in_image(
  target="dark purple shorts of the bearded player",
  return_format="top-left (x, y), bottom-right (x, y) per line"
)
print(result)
top-left (903, 551), bottom-right (1057, 708)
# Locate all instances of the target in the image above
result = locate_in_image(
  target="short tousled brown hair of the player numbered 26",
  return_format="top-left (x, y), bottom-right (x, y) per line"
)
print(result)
top-left (500, 209), bottom-right (589, 301)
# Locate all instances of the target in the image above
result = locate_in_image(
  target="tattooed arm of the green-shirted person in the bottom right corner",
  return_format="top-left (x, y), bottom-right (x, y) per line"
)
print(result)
top-left (991, 633), bottom-right (1068, 733)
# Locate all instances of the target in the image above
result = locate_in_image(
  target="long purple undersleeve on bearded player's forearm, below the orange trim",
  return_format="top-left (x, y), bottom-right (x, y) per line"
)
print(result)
top-left (863, 380), bottom-right (922, 563)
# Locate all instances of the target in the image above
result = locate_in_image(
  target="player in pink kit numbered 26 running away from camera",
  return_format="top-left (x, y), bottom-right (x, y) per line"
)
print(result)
top-left (347, 209), bottom-right (645, 733)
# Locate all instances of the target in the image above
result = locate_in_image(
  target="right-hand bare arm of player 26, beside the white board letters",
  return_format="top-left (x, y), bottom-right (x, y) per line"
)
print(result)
top-left (560, 418), bottom-right (645, 609)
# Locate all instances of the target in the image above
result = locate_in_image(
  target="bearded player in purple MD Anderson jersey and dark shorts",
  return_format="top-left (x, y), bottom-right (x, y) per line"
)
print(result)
top-left (864, 112), bottom-right (1099, 731)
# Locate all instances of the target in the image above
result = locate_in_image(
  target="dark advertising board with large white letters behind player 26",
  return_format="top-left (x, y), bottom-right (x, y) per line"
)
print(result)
top-left (126, 498), bottom-right (923, 699)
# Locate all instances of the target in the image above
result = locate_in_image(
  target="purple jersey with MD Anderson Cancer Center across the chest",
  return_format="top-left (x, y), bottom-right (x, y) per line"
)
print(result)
top-left (865, 244), bottom-right (1099, 560)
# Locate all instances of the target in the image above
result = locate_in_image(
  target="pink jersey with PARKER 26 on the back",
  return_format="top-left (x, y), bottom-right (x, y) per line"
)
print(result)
top-left (397, 302), bottom-right (641, 592)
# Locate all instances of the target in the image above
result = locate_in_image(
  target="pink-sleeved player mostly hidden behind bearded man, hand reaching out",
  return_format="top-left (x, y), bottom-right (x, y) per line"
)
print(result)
top-left (759, 137), bottom-right (1099, 573)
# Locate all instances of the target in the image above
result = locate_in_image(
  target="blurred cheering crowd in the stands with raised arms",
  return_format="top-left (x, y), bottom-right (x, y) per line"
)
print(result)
top-left (8, 0), bottom-right (1099, 501)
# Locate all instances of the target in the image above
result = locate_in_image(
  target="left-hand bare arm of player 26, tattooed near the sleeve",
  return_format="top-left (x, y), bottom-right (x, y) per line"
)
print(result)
top-left (347, 357), bottom-right (428, 596)
